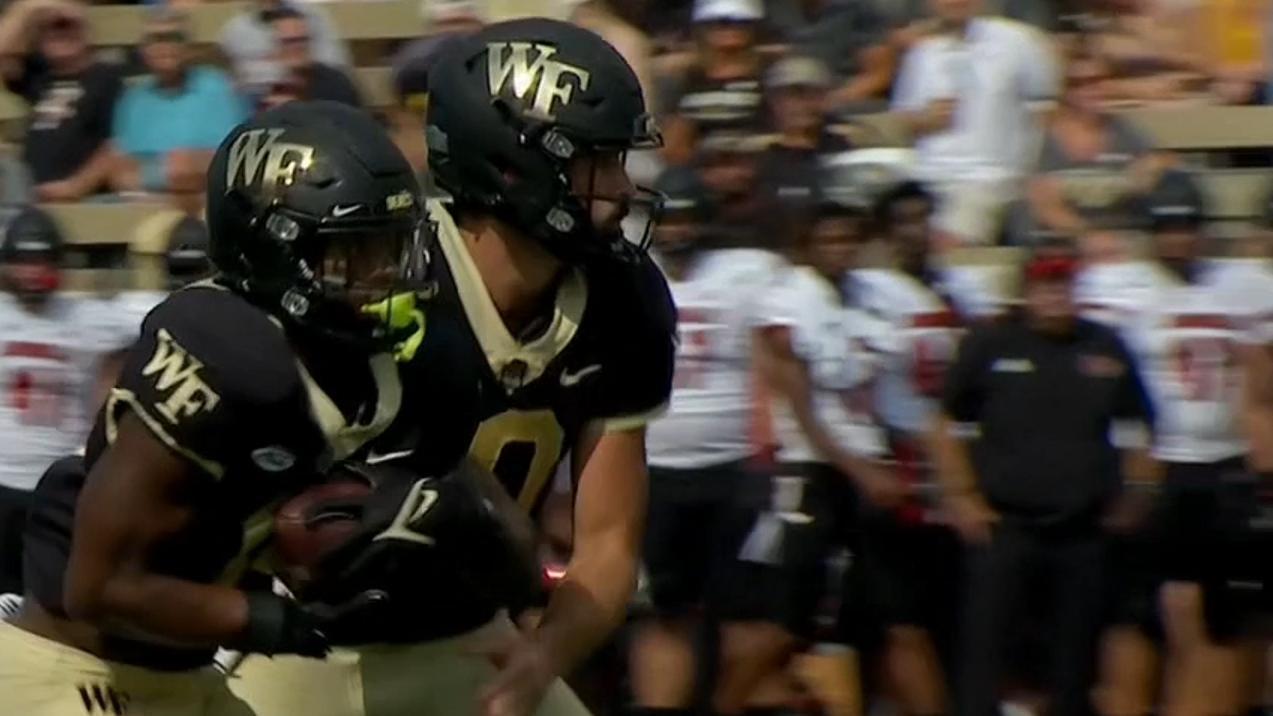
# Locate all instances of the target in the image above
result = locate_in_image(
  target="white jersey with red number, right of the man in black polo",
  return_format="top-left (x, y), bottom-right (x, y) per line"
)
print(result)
top-left (1077, 262), bottom-right (1269, 462)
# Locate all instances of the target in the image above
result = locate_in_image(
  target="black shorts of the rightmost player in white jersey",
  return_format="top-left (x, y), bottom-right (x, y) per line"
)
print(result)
top-left (1153, 459), bottom-right (1268, 638)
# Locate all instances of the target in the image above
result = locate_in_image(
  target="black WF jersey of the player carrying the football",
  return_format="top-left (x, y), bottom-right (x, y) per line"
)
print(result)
top-left (25, 283), bottom-right (402, 669)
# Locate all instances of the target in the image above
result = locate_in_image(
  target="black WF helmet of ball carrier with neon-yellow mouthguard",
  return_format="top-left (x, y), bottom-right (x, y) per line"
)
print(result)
top-left (207, 102), bottom-right (425, 350)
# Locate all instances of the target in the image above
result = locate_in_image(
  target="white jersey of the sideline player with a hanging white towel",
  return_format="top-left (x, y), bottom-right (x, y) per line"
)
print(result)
top-left (763, 266), bottom-right (889, 462)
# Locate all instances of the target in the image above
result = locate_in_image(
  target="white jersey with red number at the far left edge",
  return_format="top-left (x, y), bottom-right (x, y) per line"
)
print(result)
top-left (0, 294), bottom-right (139, 490)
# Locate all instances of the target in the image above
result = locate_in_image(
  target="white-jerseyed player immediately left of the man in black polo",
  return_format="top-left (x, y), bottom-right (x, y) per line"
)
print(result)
top-left (849, 181), bottom-right (982, 713)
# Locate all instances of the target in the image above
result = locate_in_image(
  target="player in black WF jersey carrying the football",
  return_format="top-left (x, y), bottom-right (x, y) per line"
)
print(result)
top-left (0, 102), bottom-right (421, 716)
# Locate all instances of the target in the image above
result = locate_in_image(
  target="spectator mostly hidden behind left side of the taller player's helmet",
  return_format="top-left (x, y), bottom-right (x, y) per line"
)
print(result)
top-left (388, 0), bottom-right (485, 173)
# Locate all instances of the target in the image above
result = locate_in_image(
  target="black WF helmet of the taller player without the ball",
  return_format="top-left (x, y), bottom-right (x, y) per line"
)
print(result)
top-left (426, 18), bottom-right (662, 262)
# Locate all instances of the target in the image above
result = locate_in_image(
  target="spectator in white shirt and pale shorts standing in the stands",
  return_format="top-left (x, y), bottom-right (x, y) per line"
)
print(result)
top-left (892, 0), bottom-right (1057, 243)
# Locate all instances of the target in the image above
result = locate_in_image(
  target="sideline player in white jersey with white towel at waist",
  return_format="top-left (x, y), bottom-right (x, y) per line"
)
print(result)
top-left (715, 184), bottom-right (901, 713)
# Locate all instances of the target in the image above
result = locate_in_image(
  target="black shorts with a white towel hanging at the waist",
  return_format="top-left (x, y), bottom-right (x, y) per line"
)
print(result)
top-left (713, 464), bottom-right (859, 637)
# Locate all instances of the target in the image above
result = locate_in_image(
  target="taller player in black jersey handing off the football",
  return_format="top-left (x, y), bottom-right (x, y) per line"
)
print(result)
top-left (232, 19), bottom-right (675, 716)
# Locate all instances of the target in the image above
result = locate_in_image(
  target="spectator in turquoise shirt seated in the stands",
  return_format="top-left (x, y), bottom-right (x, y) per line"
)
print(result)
top-left (112, 6), bottom-right (247, 209)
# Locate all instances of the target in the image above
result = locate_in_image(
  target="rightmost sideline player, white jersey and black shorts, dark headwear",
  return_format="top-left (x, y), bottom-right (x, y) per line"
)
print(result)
top-left (1080, 172), bottom-right (1273, 713)
